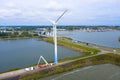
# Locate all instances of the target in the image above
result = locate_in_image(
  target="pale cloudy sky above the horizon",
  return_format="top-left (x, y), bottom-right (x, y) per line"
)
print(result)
top-left (0, 0), bottom-right (120, 25)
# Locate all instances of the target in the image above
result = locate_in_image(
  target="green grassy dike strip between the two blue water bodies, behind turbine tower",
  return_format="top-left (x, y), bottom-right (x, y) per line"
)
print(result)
top-left (43, 37), bottom-right (100, 54)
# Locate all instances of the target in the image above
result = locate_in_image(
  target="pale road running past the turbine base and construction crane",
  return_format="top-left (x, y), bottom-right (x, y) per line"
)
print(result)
top-left (0, 54), bottom-right (101, 80)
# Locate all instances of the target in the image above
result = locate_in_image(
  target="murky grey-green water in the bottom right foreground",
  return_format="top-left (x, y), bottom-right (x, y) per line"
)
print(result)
top-left (39, 64), bottom-right (120, 80)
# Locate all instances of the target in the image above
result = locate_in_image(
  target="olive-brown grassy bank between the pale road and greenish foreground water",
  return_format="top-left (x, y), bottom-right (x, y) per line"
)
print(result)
top-left (20, 53), bottom-right (120, 80)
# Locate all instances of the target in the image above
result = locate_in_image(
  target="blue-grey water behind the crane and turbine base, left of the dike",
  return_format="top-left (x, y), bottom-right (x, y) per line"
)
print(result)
top-left (0, 39), bottom-right (81, 72)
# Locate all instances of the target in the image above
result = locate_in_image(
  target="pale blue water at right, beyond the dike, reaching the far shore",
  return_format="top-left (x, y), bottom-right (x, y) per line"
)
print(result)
top-left (59, 30), bottom-right (120, 48)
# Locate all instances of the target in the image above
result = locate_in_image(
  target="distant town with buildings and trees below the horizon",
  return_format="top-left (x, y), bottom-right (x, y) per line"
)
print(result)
top-left (0, 26), bottom-right (120, 39)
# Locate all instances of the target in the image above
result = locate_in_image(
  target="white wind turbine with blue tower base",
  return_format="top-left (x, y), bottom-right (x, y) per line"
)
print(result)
top-left (49, 10), bottom-right (67, 64)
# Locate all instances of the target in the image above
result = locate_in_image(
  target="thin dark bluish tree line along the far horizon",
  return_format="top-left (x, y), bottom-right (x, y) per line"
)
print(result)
top-left (0, 25), bottom-right (120, 31)
